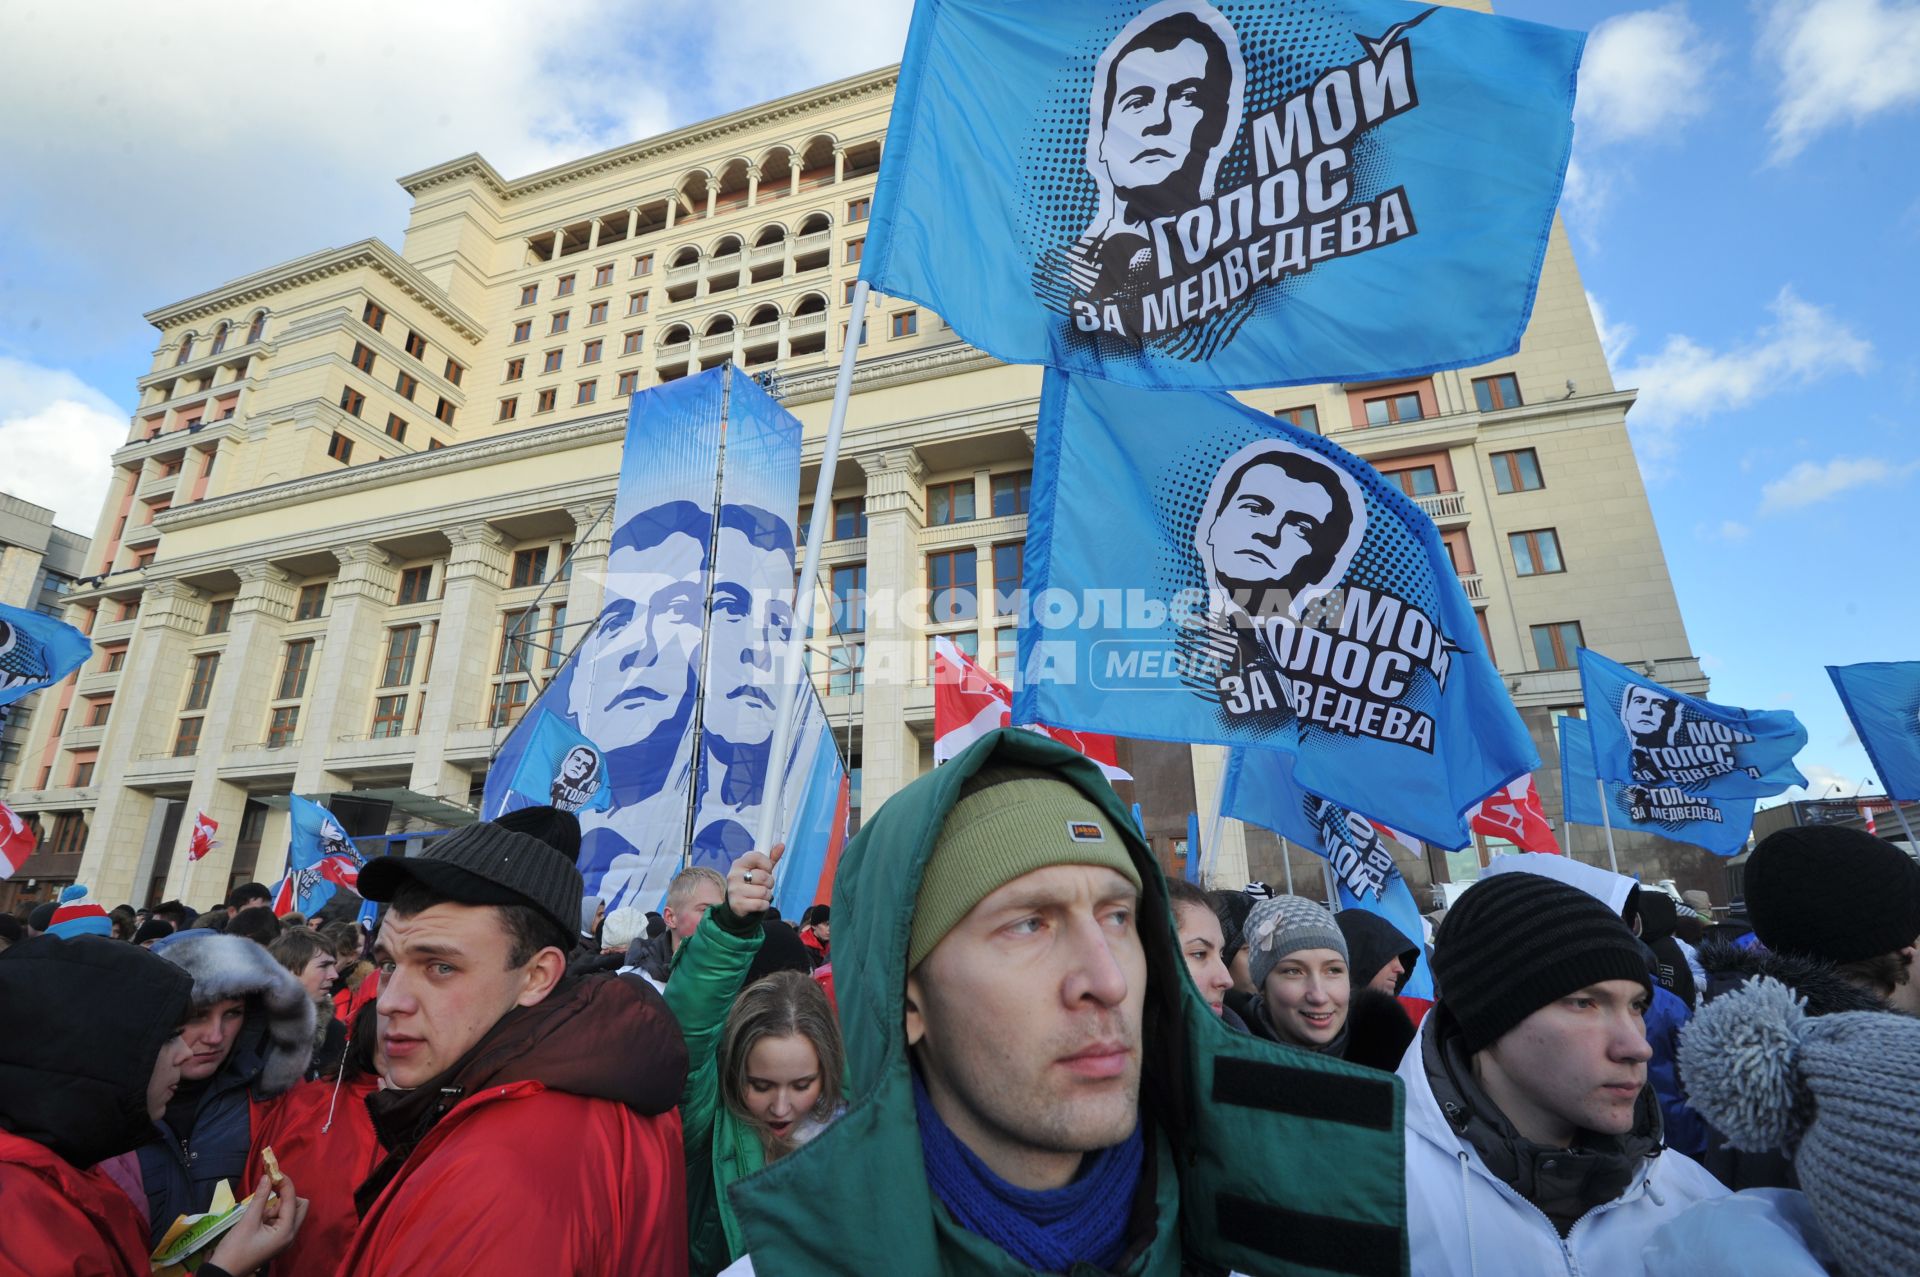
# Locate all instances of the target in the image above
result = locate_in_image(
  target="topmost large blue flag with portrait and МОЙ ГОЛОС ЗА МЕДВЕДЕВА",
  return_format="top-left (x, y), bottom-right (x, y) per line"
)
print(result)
top-left (860, 0), bottom-right (1586, 388)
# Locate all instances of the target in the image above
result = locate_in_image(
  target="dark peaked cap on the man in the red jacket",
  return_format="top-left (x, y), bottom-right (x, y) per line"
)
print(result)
top-left (359, 807), bottom-right (586, 951)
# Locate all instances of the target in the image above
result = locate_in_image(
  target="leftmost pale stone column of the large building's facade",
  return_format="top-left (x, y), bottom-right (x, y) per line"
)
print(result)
top-left (77, 580), bottom-right (207, 908)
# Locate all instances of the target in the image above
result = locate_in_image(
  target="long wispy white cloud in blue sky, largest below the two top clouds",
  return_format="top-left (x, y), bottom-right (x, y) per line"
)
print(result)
top-left (1615, 286), bottom-right (1874, 457)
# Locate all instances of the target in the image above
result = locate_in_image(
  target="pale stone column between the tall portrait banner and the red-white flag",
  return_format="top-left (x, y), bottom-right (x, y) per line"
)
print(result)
top-left (860, 447), bottom-right (927, 812)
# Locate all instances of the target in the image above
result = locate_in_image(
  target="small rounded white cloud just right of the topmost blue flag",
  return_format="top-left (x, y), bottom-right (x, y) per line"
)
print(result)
top-left (1572, 4), bottom-right (1716, 142)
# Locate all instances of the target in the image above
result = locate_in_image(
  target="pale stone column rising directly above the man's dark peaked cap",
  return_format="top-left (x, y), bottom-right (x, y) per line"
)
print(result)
top-left (409, 522), bottom-right (511, 803)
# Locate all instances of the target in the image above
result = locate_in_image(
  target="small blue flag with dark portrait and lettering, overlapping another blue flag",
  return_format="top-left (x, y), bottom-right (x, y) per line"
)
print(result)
top-left (1580, 647), bottom-right (1807, 799)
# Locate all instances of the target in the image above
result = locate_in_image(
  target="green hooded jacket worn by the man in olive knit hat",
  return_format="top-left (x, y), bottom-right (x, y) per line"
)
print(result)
top-left (732, 728), bottom-right (1407, 1277)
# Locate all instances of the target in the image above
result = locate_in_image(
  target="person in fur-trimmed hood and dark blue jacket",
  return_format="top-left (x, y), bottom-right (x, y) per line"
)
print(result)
top-left (140, 929), bottom-right (315, 1244)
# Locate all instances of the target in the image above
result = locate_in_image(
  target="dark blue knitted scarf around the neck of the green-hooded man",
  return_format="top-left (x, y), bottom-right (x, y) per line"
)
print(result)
top-left (914, 1073), bottom-right (1146, 1273)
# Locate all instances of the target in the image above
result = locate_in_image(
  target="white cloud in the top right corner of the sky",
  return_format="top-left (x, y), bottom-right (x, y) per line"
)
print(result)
top-left (1759, 0), bottom-right (1920, 163)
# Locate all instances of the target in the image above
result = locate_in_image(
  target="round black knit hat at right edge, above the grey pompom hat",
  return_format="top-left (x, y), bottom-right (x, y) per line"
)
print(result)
top-left (1745, 826), bottom-right (1920, 962)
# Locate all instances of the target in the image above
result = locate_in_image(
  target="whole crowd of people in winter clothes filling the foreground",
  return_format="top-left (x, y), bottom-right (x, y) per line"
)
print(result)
top-left (0, 730), bottom-right (1920, 1277)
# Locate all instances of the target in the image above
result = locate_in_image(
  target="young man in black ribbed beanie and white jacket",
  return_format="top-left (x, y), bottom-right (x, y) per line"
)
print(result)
top-left (1400, 874), bottom-right (1726, 1277)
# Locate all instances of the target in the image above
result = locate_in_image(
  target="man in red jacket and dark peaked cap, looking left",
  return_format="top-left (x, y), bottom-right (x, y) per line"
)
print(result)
top-left (340, 808), bottom-right (687, 1277)
